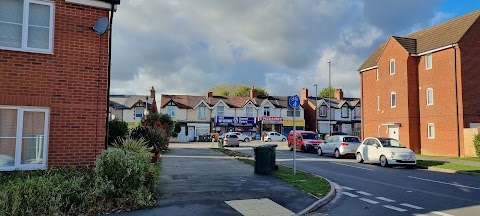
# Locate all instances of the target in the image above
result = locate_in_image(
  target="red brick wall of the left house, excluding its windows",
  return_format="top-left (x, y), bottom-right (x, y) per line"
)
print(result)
top-left (0, 0), bottom-right (109, 167)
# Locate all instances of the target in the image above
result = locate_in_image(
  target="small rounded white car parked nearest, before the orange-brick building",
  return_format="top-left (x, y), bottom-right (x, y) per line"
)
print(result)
top-left (356, 137), bottom-right (417, 167)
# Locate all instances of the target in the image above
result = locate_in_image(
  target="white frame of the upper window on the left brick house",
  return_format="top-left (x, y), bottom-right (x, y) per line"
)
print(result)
top-left (0, 0), bottom-right (55, 54)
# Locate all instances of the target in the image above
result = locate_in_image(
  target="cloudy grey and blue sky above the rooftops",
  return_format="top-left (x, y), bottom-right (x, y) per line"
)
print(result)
top-left (111, 0), bottom-right (480, 98)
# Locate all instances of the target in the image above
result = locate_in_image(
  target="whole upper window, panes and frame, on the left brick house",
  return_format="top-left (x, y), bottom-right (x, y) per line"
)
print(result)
top-left (0, 0), bottom-right (54, 52)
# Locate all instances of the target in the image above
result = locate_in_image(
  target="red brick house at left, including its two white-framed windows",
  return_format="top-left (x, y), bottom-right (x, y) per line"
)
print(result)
top-left (0, 0), bottom-right (119, 171)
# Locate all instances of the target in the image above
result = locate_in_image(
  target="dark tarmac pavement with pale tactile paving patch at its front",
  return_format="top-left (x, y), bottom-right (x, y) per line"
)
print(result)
top-left (115, 143), bottom-right (334, 216)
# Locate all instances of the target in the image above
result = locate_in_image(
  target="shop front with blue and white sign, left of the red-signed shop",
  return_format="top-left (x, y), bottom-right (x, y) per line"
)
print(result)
top-left (214, 116), bottom-right (257, 137)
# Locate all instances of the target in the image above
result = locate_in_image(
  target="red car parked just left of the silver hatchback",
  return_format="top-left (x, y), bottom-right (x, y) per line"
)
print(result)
top-left (288, 130), bottom-right (323, 152)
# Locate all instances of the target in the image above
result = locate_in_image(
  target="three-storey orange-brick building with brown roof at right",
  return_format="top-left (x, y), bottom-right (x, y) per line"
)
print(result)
top-left (359, 10), bottom-right (480, 156)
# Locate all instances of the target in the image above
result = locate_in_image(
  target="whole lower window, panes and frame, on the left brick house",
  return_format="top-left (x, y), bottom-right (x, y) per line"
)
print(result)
top-left (0, 107), bottom-right (49, 170)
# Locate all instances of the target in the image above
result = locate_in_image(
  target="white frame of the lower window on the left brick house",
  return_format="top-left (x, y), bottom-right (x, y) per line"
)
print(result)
top-left (0, 106), bottom-right (50, 171)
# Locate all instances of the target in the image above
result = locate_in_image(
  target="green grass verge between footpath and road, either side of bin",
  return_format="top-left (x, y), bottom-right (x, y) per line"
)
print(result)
top-left (213, 148), bottom-right (330, 198)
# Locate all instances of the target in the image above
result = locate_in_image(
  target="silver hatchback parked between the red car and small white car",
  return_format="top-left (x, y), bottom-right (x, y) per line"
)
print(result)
top-left (317, 135), bottom-right (361, 158)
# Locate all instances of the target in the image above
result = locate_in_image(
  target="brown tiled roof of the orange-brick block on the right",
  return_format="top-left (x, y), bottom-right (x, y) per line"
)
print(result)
top-left (358, 10), bottom-right (480, 71)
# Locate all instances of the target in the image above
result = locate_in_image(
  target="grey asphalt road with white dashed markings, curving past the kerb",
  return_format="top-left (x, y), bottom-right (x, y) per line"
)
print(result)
top-left (230, 142), bottom-right (480, 216)
